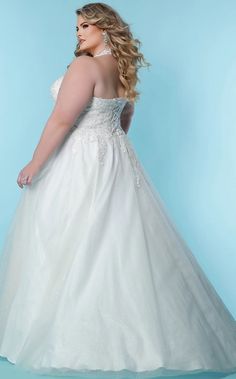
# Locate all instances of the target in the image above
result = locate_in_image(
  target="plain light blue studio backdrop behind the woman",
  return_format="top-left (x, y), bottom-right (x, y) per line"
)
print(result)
top-left (0, 0), bottom-right (236, 326)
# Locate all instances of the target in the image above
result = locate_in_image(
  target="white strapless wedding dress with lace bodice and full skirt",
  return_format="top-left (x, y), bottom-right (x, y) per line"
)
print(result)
top-left (0, 77), bottom-right (236, 378)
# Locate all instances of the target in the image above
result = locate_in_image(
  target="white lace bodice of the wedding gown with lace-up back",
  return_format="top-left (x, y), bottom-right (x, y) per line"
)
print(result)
top-left (50, 75), bottom-right (140, 187)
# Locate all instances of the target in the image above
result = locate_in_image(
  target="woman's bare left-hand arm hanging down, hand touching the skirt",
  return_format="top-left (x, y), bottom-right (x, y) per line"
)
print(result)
top-left (17, 56), bottom-right (96, 188)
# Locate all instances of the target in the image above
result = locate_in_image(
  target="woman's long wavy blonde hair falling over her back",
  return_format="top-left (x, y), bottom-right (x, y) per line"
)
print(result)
top-left (67, 3), bottom-right (150, 102)
